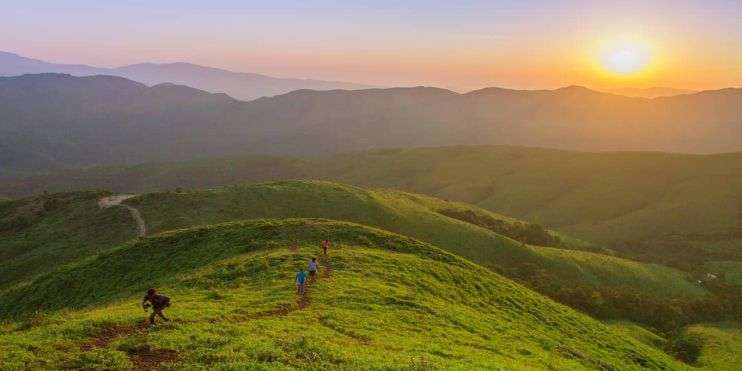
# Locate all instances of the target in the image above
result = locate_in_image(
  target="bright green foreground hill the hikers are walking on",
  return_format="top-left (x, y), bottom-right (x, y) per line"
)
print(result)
top-left (0, 219), bottom-right (685, 370)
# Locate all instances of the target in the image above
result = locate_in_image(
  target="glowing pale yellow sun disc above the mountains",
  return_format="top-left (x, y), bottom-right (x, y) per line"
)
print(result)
top-left (601, 42), bottom-right (651, 76)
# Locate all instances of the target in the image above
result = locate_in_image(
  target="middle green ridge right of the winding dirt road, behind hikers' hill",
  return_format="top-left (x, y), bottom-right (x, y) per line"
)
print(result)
top-left (127, 181), bottom-right (706, 298)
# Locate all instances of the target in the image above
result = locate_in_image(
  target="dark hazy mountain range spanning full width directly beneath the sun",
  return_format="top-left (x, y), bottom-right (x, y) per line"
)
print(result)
top-left (0, 74), bottom-right (742, 176)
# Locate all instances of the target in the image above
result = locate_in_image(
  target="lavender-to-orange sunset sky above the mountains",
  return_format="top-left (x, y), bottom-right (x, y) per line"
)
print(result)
top-left (0, 0), bottom-right (742, 90)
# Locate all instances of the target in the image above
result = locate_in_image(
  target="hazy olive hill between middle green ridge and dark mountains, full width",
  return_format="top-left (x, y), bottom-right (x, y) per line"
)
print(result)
top-left (0, 146), bottom-right (742, 269)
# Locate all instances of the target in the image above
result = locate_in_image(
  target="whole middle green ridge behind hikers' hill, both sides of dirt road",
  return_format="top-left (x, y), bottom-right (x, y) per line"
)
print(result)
top-left (0, 181), bottom-right (710, 330)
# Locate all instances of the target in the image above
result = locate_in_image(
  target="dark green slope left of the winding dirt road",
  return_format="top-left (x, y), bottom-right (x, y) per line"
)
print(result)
top-left (0, 192), bottom-right (136, 290)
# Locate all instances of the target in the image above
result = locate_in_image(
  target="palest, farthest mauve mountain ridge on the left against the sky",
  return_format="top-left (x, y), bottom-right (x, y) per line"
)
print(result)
top-left (0, 51), bottom-right (372, 100)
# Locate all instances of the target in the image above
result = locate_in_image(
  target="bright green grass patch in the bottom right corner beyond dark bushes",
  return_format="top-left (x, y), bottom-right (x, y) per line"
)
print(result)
top-left (687, 322), bottom-right (742, 370)
